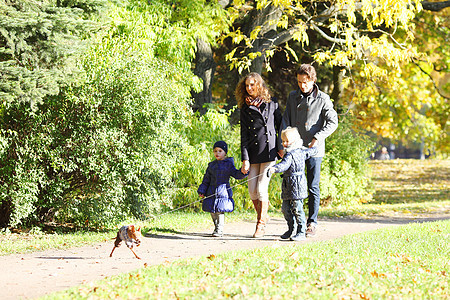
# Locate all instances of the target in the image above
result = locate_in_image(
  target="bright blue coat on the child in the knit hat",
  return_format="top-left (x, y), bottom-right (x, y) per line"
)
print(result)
top-left (197, 157), bottom-right (247, 213)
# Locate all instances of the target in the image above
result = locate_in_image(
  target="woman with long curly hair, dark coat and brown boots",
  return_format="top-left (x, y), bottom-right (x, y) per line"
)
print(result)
top-left (235, 73), bottom-right (282, 238)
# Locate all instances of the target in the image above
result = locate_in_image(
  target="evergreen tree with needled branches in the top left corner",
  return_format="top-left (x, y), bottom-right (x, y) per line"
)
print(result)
top-left (0, 0), bottom-right (104, 110)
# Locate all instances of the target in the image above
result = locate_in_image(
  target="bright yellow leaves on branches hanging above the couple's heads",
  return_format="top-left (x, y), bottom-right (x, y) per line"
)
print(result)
top-left (223, 0), bottom-right (421, 76)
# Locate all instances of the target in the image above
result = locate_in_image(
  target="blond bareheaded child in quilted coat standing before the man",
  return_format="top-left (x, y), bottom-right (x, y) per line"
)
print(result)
top-left (267, 127), bottom-right (317, 241)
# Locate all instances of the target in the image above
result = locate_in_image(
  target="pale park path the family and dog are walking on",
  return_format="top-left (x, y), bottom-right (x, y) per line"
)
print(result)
top-left (0, 218), bottom-right (446, 299)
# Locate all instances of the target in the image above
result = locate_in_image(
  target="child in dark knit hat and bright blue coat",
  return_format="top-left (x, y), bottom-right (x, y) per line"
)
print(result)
top-left (197, 141), bottom-right (247, 237)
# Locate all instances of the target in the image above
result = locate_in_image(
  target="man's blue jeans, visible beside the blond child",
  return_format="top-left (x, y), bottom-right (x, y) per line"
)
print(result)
top-left (306, 157), bottom-right (323, 225)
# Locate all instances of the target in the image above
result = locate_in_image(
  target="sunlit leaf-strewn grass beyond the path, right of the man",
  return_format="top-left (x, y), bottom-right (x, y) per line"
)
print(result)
top-left (320, 159), bottom-right (450, 218)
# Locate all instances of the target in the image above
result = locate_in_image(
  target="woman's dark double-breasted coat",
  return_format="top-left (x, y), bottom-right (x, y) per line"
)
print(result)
top-left (241, 100), bottom-right (282, 164)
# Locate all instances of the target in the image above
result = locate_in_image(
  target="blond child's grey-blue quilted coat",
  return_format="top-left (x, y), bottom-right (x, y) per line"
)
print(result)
top-left (273, 147), bottom-right (317, 200)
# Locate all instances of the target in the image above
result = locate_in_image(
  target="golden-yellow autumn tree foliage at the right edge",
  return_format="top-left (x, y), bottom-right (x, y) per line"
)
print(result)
top-left (342, 9), bottom-right (450, 158)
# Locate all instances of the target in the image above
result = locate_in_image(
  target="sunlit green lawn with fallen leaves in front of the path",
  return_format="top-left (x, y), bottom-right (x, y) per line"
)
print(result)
top-left (44, 220), bottom-right (450, 299)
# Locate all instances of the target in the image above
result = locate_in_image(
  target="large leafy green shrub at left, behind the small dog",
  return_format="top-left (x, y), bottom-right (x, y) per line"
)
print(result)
top-left (0, 0), bottom-right (200, 227)
